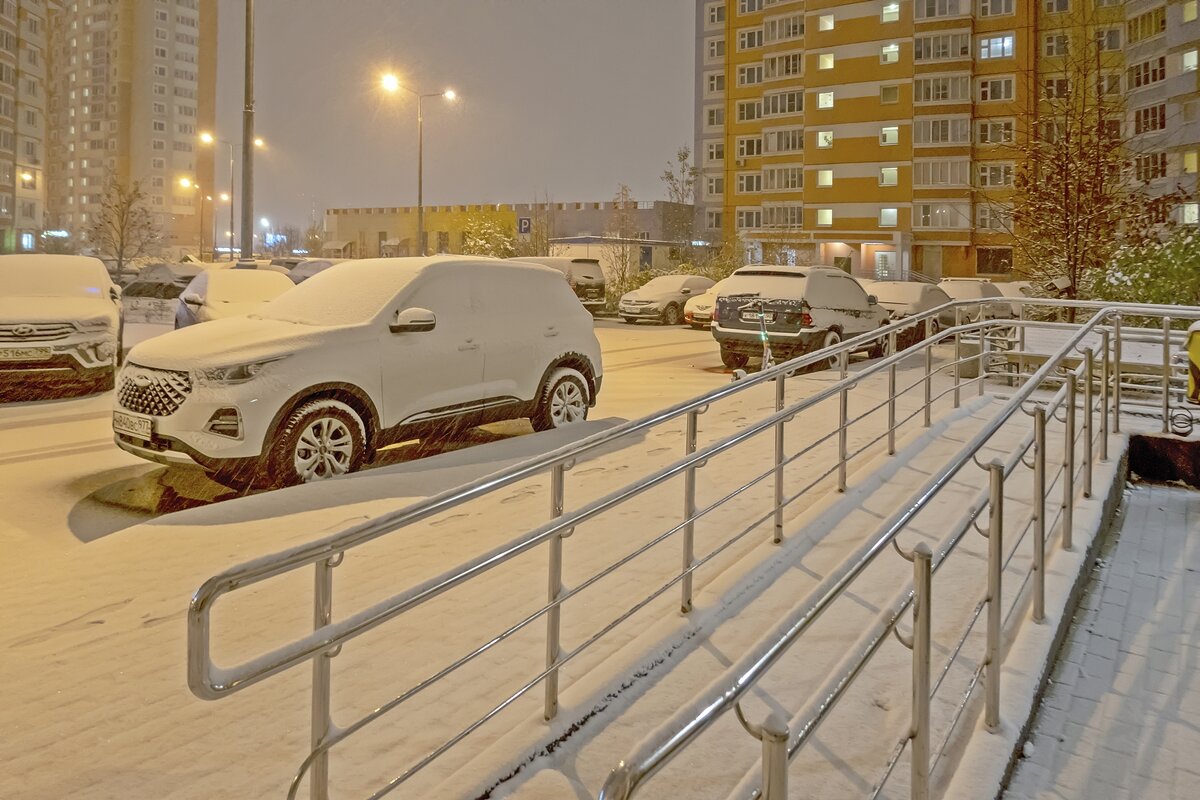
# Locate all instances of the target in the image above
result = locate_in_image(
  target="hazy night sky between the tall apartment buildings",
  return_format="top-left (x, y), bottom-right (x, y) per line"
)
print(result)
top-left (216, 0), bottom-right (695, 227)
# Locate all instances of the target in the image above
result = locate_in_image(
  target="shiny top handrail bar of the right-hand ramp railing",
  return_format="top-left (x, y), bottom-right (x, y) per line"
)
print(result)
top-left (599, 301), bottom-right (1200, 800)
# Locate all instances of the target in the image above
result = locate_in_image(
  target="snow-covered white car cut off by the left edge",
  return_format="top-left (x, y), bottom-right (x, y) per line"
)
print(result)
top-left (0, 254), bottom-right (122, 397)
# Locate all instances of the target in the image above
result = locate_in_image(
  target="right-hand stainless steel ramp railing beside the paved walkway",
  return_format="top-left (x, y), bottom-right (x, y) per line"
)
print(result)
top-left (600, 301), bottom-right (1200, 800)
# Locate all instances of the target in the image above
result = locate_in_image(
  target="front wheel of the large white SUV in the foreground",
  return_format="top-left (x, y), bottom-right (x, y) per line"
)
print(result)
top-left (270, 399), bottom-right (366, 486)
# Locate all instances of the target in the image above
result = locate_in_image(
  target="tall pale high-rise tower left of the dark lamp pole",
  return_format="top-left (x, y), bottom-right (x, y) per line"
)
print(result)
top-left (48, 0), bottom-right (217, 251)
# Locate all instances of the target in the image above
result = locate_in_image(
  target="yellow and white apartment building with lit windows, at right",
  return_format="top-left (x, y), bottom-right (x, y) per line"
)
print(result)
top-left (695, 0), bottom-right (1200, 277)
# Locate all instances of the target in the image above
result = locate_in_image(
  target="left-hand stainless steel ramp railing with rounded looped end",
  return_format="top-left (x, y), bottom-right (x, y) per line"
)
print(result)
top-left (188, 301), bottom-right (1195, 799)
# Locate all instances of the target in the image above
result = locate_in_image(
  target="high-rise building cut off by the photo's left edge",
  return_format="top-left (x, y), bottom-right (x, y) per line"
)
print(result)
top-left (0, 0), bottom-right (47, 253)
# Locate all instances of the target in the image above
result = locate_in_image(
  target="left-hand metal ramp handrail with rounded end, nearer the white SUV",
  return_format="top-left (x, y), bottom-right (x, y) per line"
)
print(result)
top-left (188, 300), bottom-right (1200, 798)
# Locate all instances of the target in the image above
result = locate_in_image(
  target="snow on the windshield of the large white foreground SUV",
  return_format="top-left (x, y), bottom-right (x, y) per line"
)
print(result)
top-left (251, 260), bottom-right (418, 325)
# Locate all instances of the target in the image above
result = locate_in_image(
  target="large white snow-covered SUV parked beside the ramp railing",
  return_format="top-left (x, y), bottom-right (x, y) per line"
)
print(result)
top-left (113, 255), bottom-right (602, 485)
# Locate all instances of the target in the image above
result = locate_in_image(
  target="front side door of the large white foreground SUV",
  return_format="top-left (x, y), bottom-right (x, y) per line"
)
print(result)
top-left (378, 264), bottom-right (484, 428)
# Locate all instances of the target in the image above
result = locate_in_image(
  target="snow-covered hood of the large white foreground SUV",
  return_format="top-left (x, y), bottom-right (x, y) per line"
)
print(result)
top-left (128, 317), bottom-right (352, 369)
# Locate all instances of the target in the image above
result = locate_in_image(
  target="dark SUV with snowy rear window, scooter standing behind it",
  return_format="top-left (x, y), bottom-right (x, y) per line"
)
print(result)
top-left (712, 264), bottom-right (888, 369)
